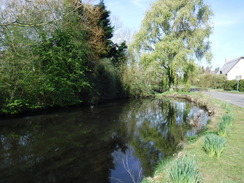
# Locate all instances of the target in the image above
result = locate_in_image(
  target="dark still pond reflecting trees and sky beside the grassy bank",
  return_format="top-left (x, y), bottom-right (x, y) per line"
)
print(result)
top-left (0, 99), bottom-right (208, 183)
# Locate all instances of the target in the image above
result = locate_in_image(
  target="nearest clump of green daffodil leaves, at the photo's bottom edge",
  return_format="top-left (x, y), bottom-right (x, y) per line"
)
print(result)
top-left (170, 156), bottom-right (200, 183)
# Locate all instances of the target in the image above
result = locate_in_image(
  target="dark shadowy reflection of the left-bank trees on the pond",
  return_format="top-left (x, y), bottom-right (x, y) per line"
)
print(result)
top-left (0, 113), bottom-right (124, 183)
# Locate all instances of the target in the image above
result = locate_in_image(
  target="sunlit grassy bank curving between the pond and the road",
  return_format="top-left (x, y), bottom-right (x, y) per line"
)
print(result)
top-left (143, 93), bottom-right (244, 183)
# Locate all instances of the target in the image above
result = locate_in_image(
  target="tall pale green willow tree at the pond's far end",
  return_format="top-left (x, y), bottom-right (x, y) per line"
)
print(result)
top-left (132, 0), bottom-right (212, 88)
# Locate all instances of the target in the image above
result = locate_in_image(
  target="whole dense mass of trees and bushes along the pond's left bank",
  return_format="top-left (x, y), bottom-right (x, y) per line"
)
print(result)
top-left (0, 1), bottom-right (127, 114)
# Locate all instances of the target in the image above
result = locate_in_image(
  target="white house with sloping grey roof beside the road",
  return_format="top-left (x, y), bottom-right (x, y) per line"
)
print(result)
top-left (218, 57), bottom-right (244, 80)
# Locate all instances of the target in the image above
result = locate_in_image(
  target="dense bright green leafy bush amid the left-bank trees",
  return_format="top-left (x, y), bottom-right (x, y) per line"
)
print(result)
top-left (35, 29), bottom-right (91, 106)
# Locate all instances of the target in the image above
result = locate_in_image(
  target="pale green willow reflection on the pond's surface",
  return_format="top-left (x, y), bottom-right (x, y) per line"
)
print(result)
top-left (118, 100), bottom-right (204, 176)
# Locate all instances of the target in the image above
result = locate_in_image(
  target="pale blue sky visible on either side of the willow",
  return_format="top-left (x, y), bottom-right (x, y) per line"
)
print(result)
top-left (104, 0), bottom-right (244, 69)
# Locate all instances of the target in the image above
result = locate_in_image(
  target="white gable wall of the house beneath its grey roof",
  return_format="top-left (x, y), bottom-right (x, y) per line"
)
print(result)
top-left (227, 59), bottom-right (244, 80)
